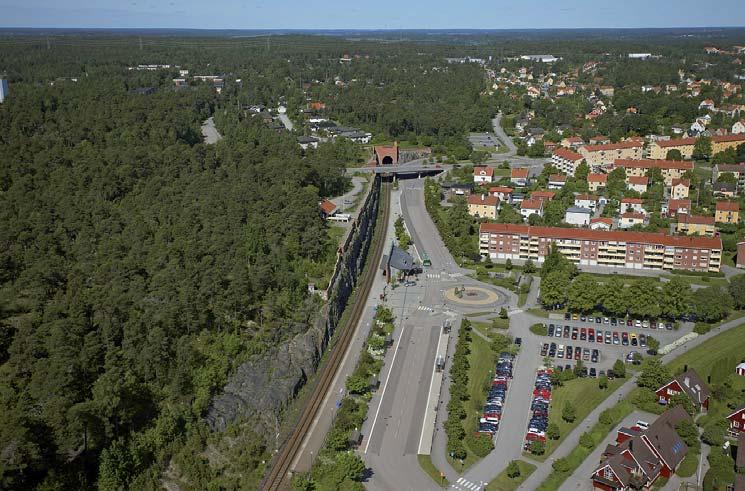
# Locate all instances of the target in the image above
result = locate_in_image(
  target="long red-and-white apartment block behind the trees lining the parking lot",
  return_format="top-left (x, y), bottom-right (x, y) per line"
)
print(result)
top-left (479, 223), bottom-right (722, 271)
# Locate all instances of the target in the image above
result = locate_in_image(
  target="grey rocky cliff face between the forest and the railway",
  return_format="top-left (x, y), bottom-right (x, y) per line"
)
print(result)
top-left (206, 180), bottom-right (380, 441)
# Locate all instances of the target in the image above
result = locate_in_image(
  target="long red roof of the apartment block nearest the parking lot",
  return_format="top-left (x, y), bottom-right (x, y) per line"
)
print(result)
top-left (479, 223), bottom-right (722, 250)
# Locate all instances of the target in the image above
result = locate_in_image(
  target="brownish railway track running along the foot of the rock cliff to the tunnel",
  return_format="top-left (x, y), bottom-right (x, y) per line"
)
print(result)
top-left (262, 183), bottom-right (391, 491)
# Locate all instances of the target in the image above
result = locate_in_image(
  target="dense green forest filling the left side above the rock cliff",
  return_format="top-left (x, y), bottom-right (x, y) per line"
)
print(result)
top-left (0, 37), bottom-right (354, 489)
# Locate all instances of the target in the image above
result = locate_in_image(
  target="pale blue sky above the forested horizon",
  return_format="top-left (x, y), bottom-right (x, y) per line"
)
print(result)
top-left (0, 0), bottom-right (745, 29)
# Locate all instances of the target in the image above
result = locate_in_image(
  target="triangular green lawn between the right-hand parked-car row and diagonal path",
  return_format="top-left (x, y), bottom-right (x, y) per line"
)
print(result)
top-left (533, 378), bottom-right (626, 461)
